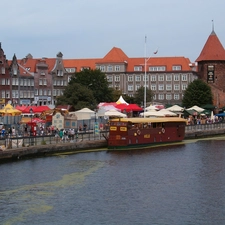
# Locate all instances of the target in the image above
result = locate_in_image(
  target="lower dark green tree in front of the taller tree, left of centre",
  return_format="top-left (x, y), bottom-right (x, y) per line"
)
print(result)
top-left (57, 83), bottom-right (97, 110)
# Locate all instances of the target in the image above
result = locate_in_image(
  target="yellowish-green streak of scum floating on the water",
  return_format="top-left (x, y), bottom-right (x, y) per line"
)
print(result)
top-left (0, 161), bottom-right (104, 225)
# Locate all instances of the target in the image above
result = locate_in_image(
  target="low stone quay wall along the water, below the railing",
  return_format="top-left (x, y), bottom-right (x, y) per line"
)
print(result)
top-left (0, 124), bottom-right (225, 161)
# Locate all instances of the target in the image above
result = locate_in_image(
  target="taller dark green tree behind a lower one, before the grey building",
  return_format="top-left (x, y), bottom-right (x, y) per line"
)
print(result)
top-left (69, 69), bottom-right (113, 104)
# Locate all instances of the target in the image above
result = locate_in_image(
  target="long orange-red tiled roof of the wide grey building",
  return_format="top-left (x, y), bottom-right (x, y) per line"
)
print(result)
top-left (10, 47), bottom-right (191, 75)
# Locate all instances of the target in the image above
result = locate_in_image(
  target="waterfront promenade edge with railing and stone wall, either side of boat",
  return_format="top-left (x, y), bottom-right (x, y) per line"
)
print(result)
top-left (0, 123), bottom-right (225, 160)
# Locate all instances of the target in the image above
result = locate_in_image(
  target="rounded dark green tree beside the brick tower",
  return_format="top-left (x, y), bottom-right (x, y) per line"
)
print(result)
top-left (182, 79), bottom-right (213, 108)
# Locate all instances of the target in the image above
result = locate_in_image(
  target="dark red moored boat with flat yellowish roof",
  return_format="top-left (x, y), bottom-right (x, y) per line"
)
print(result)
top-left (108, 117), bottom-right (187, 149)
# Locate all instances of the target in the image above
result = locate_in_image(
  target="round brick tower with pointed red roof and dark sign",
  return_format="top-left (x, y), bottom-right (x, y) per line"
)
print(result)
top-left (196, 27), bottom-right (225, 110)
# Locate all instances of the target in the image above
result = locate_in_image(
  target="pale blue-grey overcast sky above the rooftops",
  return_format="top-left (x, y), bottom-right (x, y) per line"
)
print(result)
top-left (0, 0), bottom-right (225, 62)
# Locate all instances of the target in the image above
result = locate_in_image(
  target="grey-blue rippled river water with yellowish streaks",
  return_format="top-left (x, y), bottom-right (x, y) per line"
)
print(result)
top-left (0, 137), bottom-right (225, 225)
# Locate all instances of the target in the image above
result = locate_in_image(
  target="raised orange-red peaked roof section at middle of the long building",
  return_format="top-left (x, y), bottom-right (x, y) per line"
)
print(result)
top-left (100, 47), bottom-right (128, 63)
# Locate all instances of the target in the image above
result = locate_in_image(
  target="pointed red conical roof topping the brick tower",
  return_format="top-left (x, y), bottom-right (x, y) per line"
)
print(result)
top-left (196, 30), bottom-right (225, 62)
